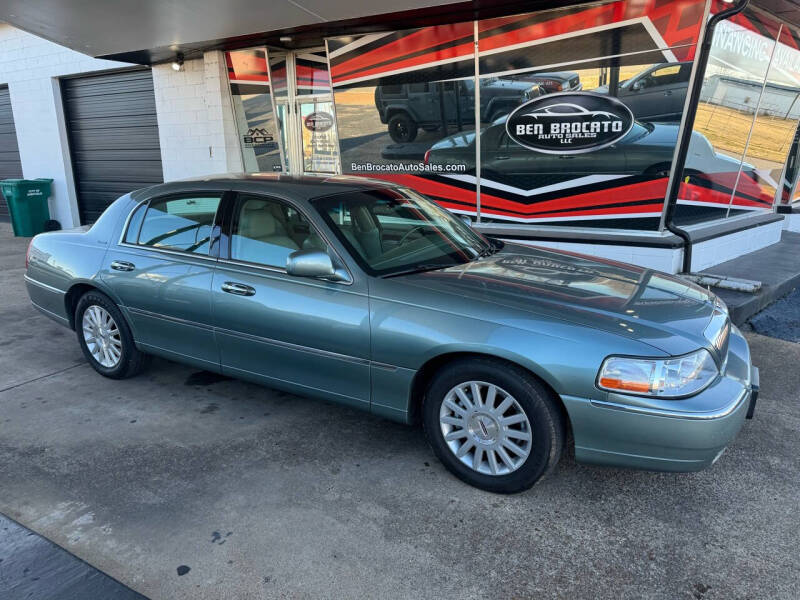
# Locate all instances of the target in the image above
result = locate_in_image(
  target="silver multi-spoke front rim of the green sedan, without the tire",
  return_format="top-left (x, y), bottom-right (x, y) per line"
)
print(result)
top-left (439, 381), bottom-right (533, 475)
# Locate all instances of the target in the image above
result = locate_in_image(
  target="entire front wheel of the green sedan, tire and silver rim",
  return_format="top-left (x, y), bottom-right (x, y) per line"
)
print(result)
top-left (423, 359), bottom-right (566, 494)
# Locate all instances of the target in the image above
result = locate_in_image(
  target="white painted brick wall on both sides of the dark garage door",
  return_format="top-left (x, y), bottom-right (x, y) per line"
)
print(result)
top-left (0, 23), bottom-right (242, 228)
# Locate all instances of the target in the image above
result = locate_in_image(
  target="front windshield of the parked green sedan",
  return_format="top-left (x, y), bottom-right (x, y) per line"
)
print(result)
top-left (313, 188), bottom-right (495, 277)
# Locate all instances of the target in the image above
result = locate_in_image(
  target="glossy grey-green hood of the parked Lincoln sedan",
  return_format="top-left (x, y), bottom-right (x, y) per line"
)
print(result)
top-left (392, 244), bottom-right (715, 355)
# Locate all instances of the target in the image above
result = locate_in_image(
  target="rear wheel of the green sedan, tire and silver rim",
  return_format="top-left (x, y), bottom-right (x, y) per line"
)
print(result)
top-left (75, 291), bottom-right (147, 379)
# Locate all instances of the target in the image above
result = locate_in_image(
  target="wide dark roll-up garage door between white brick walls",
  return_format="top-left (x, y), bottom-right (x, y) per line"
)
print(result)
top-left (61, 69), bottom-right (163, 223)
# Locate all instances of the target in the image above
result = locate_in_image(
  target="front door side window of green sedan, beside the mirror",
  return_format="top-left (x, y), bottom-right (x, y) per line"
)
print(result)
top-left (231, 196), bottom-right (328, 269)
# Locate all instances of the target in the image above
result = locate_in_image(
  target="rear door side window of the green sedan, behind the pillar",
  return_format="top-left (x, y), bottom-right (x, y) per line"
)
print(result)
top-left (134, 196), bottom-right (220, 254)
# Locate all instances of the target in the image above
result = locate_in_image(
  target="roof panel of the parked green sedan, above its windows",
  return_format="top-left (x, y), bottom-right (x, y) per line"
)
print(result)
top-left (131, 173), bottom-right (400, 201)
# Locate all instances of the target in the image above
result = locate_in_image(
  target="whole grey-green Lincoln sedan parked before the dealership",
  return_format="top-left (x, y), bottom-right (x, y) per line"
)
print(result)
top-left (25, 175), bottom-right (758, 493)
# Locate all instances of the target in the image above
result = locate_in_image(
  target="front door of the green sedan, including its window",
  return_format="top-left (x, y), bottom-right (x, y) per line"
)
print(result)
top-left (212, 194), bottom-right (370, 406)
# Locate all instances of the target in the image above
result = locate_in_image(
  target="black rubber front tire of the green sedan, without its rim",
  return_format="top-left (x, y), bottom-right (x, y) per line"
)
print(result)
top-left (422, 358), bottom-right (567, 494)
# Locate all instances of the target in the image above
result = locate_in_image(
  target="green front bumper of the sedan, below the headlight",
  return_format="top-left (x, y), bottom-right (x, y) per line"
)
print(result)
top-left (562, 328), bottom-right (759, 471)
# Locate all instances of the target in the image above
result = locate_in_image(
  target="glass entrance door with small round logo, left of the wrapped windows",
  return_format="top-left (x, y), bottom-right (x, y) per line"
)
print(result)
top-left (267, 48), bottom-right (340, 175)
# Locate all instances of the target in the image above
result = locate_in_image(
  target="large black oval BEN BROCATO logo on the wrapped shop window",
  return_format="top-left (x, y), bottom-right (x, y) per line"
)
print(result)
top-left (506, 92), bottom-right (634, 154)
